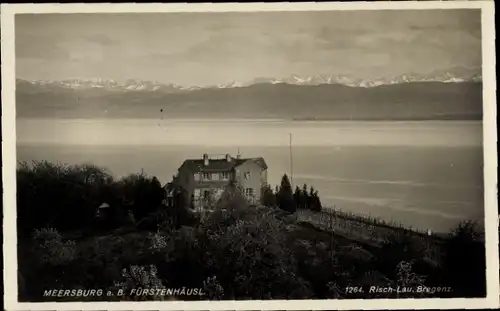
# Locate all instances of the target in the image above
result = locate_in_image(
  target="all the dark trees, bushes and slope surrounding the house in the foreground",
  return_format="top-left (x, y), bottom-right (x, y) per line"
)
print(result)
top-left (17, 162), bottom-right (486, 301)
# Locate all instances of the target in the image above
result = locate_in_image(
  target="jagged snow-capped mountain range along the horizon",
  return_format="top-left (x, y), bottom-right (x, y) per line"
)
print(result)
top-left (17, 67), bottom-right (482, 93)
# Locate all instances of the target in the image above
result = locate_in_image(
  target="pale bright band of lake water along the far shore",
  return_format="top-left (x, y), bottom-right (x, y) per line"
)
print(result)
top-left (17, 119), bottom-right (482, 147)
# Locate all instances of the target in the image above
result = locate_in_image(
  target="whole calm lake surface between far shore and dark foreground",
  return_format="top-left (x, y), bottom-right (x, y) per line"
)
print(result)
top-left (16, 119), bottom-right (484, 231)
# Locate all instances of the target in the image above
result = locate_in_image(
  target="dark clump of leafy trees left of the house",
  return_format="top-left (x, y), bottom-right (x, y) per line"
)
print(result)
top-left (17, 161), bottom-right (170, 236)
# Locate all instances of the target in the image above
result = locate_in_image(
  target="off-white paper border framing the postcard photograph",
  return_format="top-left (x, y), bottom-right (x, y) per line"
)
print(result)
top-left (1, 1), bottom-right (500, 310)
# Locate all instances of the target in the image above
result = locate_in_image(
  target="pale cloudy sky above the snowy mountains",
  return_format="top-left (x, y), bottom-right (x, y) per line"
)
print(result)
top-left (15, 9), bottom-right (481, 85)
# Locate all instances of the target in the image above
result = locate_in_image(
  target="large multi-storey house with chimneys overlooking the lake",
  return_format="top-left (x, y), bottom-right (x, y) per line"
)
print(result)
top-left (172, 154), bottom-right (267, 210)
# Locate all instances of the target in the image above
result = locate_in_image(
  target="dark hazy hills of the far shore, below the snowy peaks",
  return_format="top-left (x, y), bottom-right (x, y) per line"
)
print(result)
top-left (16, 80), bottom-right (482, 120)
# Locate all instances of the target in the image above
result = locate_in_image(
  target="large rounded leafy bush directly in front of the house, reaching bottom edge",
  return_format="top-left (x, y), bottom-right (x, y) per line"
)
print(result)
top-left (198, 202), bottom-right (312, 299)
